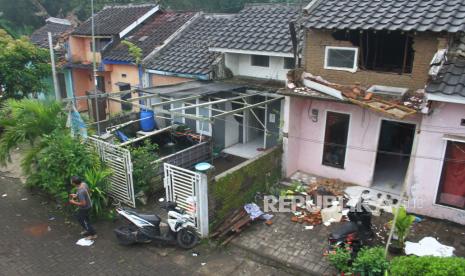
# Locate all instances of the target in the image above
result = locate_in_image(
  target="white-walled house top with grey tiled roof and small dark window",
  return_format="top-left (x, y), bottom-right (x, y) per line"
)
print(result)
top-left (210, 4), bottom-right (299, 81)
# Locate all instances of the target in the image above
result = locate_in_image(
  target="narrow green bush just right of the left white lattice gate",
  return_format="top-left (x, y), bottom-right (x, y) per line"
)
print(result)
top-left (130, 140), bottom-right (162, 194)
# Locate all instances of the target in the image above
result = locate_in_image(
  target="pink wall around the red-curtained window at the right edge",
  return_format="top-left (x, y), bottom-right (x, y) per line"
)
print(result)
top-left (409, 102), bottom-right (465, 224)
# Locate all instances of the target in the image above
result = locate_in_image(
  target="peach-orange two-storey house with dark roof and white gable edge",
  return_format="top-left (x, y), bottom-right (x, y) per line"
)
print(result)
top-left (65, 4), bottom-right (160, 112)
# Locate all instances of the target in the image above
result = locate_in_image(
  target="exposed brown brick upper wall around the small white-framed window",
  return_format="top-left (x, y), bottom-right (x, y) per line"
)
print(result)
top-left (304, 30), bottom-right (445, 90)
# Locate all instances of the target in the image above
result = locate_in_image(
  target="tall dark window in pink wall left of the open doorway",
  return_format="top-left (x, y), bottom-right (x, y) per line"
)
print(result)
top-left (323, 112), bottom-right (350, 169)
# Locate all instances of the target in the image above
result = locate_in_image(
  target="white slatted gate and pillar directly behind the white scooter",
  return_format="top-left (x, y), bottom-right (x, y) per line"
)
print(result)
top-left (163, 163), bottom-right (208, 237)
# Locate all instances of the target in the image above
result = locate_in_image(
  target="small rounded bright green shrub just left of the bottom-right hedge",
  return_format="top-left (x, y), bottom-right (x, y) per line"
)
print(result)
top-left (352, 247), bottom-right (389, 276)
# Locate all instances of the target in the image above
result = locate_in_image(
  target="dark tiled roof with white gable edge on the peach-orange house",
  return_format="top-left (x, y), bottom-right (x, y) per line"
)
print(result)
top-left (73, 4), bottom-right (157, 36)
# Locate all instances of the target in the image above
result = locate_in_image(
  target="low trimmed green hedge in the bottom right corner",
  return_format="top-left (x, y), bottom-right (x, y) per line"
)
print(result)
top-left (390, 256), bottom-right (465, 276)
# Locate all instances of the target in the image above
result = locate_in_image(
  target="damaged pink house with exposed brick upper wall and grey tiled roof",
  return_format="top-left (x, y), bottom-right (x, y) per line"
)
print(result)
top-left (281, 0), bottom-right (465, 224)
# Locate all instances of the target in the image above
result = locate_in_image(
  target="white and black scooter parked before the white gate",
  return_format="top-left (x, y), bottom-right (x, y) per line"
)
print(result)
top-left (113, 200), bottom-right (199, 249)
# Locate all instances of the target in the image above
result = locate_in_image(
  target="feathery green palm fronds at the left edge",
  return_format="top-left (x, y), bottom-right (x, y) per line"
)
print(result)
top-left (0, 99), bottom-right (66, 172)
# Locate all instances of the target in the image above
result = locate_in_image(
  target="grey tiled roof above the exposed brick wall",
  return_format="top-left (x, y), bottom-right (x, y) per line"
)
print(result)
top-left (303, 0), bottom-right (465, 33)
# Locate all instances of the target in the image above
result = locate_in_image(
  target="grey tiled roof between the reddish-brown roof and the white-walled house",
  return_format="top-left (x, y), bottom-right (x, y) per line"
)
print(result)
top-left (145, 15), bottom-right (230, 75)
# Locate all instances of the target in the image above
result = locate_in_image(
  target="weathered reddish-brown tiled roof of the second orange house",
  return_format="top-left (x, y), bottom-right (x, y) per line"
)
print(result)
top-left (103, 12), bottom-right (195, 62)
